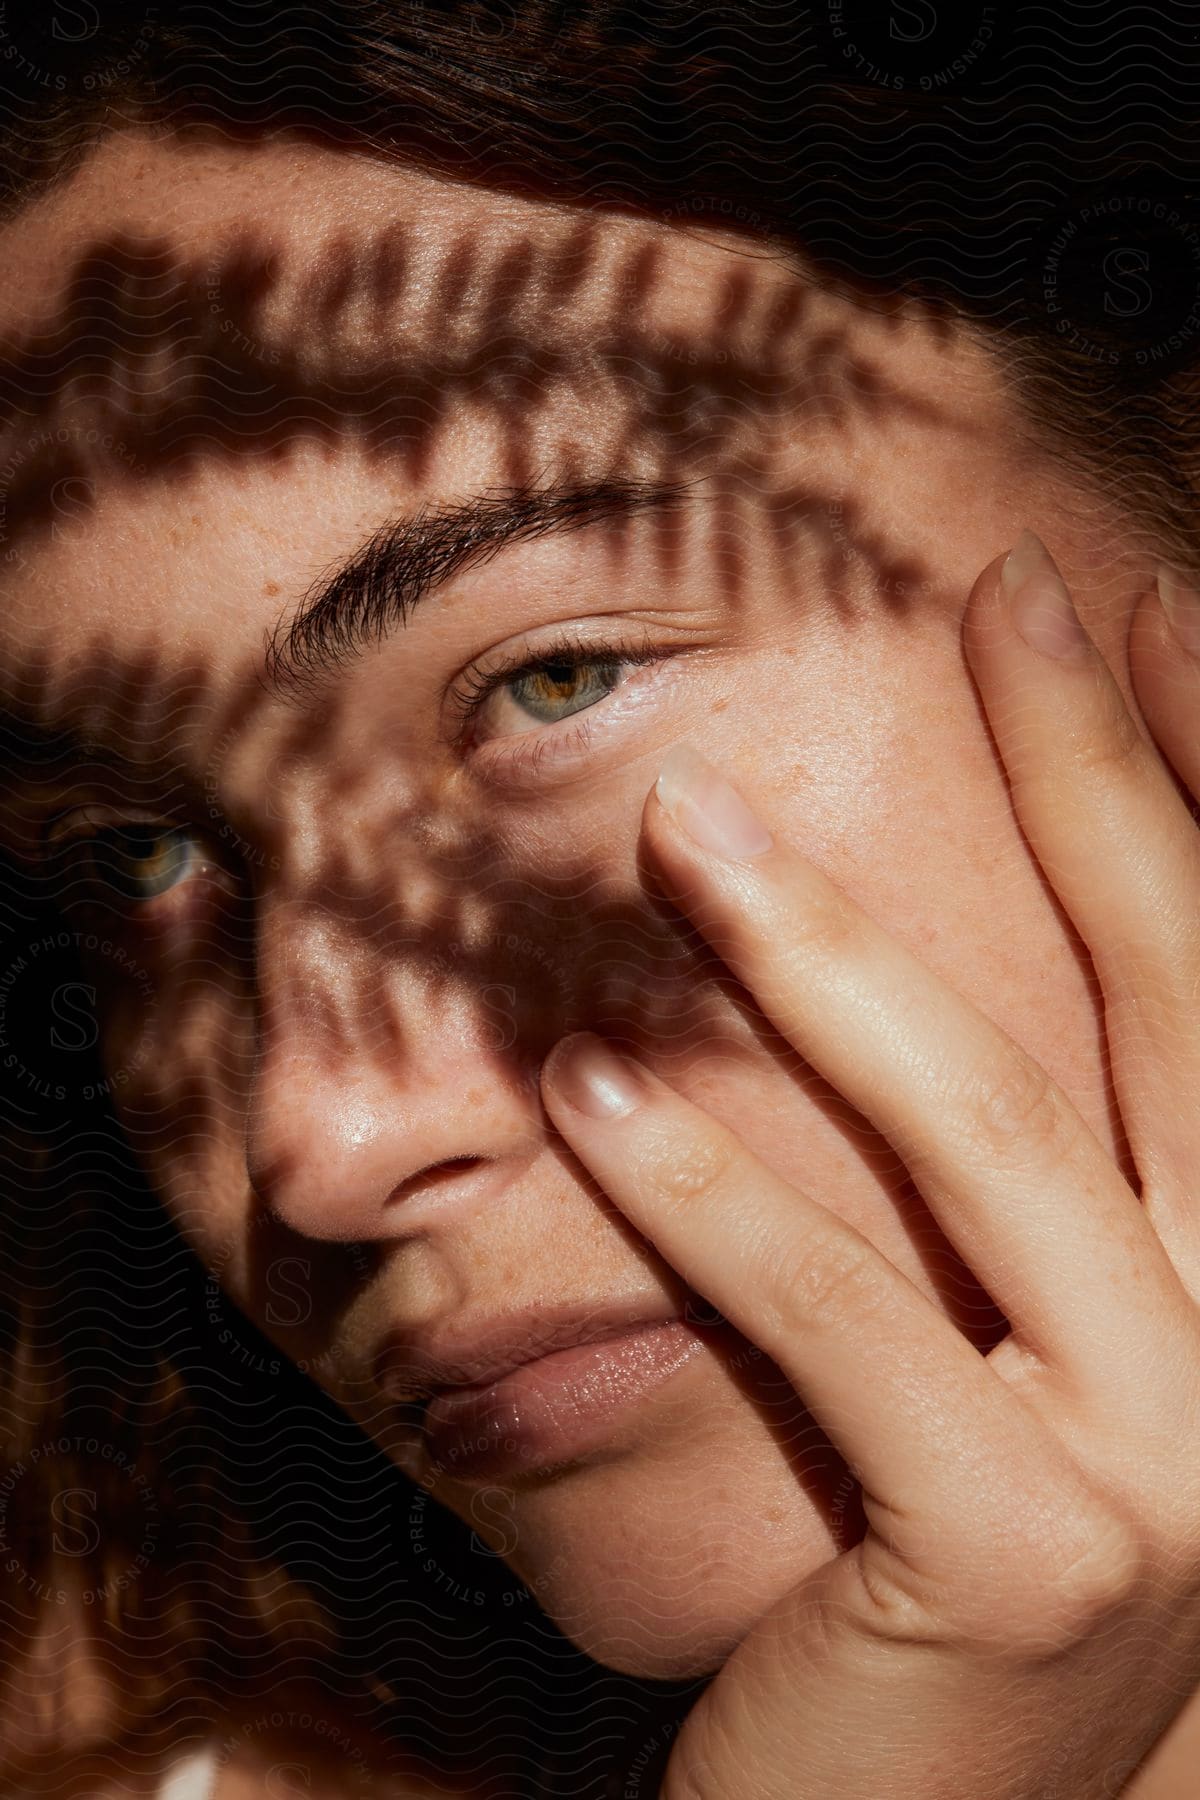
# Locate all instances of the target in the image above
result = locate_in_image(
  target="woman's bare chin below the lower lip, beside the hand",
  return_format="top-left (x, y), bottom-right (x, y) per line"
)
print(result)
top-left (413, 1354), bottom-right (852, 1681)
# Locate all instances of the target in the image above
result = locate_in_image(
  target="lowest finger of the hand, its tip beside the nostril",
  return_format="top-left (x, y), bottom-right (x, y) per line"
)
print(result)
top-left (542, 1031), bottom-right (1086, 1573)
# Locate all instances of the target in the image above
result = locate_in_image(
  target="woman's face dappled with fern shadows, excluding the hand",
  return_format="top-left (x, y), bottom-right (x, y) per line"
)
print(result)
top-left (0, 135), bottom-right (1173, 1676)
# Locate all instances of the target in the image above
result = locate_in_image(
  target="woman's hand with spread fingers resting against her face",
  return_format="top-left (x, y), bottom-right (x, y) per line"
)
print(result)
top-left (542, 535), bottom-right (1200, 1800)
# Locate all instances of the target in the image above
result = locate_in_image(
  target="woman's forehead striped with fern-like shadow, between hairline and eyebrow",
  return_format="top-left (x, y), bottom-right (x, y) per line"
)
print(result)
top-left (0, 131), bottom-right (1007, 745)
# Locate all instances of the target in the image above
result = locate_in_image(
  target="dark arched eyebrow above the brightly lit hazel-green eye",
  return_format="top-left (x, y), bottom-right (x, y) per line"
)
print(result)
top-left (264, 477), bottom-right (698, 697)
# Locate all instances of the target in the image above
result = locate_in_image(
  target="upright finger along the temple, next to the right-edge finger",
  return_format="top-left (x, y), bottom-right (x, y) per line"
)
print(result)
top-left (963, 533), bottom-right (1200, 1202)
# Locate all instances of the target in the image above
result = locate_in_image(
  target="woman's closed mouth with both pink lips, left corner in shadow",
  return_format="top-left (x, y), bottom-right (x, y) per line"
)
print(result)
top-left (378, 1307), bottom-right (712, 1481)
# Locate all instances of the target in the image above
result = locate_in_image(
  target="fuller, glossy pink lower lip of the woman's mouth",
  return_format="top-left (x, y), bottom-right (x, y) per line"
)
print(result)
top-left (425, 1319), bottom-right (702, 1480)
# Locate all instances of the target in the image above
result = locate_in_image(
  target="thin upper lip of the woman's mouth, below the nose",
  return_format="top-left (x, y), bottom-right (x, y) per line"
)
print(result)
top-left (374, 1300), bottom-right (680, 1402)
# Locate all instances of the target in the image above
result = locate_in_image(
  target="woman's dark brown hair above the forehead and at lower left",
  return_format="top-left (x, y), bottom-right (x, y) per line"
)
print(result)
top-left (0, 0), bottom-right (1200, 1778)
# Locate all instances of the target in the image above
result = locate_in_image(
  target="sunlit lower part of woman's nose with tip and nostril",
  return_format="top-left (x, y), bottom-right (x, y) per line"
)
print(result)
top-left (246, 911), bottom-right (543, 1242)
